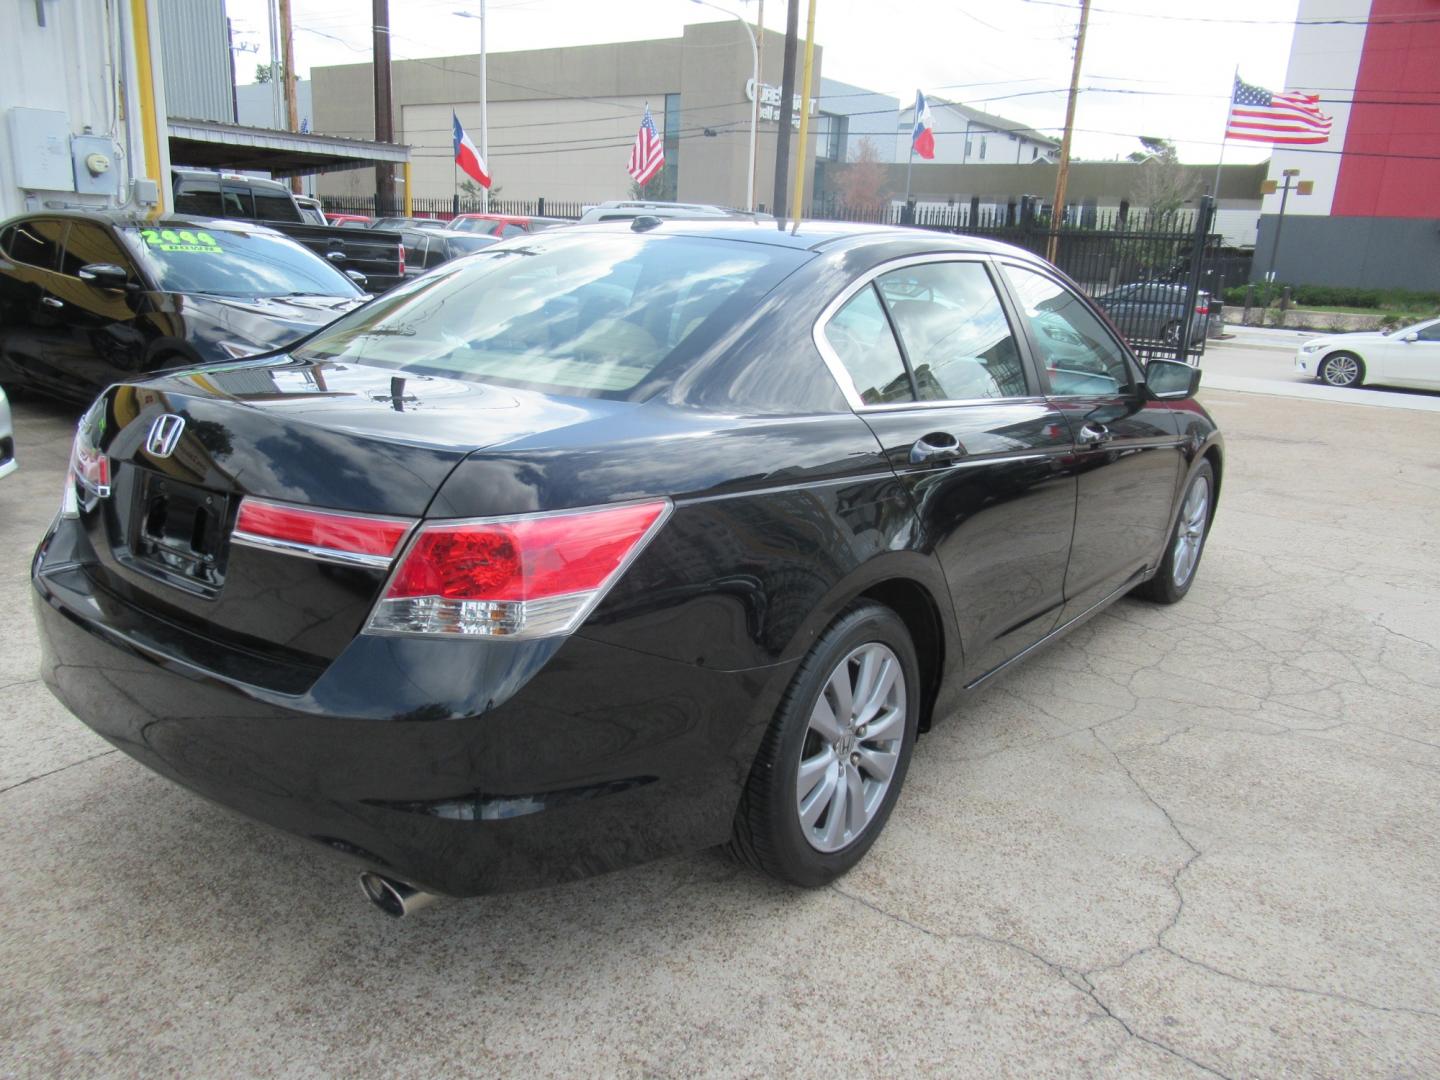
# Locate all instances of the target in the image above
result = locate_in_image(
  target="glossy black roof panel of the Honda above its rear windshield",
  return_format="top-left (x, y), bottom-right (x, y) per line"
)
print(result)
top-left (573, 217), bottom-right (1037, 259)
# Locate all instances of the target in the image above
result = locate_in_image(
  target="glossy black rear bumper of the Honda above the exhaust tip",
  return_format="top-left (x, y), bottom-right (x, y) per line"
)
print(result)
top-left (33, 524), bottom-right (795, 896)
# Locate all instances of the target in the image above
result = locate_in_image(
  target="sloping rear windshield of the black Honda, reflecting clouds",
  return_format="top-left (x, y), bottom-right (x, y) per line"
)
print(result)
top-left (294, 230), bottom-right (809, 399)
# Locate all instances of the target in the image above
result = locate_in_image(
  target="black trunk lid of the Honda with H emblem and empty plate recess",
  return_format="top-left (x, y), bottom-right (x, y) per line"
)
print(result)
top-left (74, 357), bottom-right (634, 662)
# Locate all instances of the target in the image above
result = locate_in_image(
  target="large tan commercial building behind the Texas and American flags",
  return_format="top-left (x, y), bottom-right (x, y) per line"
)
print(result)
top-left (311, 22), bottom-right (825, 206)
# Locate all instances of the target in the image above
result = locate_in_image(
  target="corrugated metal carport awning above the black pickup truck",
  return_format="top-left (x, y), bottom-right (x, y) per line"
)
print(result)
top-left (170, 118), bottom-right (410, 176)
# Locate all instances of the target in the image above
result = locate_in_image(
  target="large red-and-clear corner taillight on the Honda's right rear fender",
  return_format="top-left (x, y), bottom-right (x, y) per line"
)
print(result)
top-left (369, 501), bottom-right (670, 638)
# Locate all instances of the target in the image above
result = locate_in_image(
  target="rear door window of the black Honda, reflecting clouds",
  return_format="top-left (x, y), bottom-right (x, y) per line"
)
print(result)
top-left (876, 262), bottom-right (1030, 402)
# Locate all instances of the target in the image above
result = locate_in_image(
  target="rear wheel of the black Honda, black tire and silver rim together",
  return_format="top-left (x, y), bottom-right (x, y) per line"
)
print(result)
top-left (727, 602), bottom-right (920, 888)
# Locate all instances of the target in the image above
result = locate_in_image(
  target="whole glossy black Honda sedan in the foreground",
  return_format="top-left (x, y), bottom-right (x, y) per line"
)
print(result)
top-left (33, 219), bottom-right (1221, 913)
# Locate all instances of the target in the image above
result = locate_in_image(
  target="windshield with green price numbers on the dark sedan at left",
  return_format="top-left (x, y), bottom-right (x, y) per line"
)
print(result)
top-left (121, 225), bottom-right (360, 297)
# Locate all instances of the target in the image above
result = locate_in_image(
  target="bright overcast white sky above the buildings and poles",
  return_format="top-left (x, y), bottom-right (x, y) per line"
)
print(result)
top-left (226, 0), bottom-right (1297, 163)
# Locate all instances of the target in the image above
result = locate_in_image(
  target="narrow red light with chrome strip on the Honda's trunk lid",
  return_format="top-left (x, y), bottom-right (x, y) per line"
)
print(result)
top-left (235, 498), bottom-right (415, 566)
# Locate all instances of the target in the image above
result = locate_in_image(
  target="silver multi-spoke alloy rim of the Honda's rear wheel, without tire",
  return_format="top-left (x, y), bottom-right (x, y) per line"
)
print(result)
top-left (795, 641), bottom-right (906, 852)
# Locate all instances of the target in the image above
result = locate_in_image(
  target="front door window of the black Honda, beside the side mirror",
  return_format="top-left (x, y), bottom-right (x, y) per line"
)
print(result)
top-left (1005, 264), bottom-right (1135, 396)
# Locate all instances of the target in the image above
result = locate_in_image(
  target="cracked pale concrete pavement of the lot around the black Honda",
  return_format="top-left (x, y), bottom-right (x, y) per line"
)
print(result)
top-left (0, 392), bottom-right (1440, 1076)
